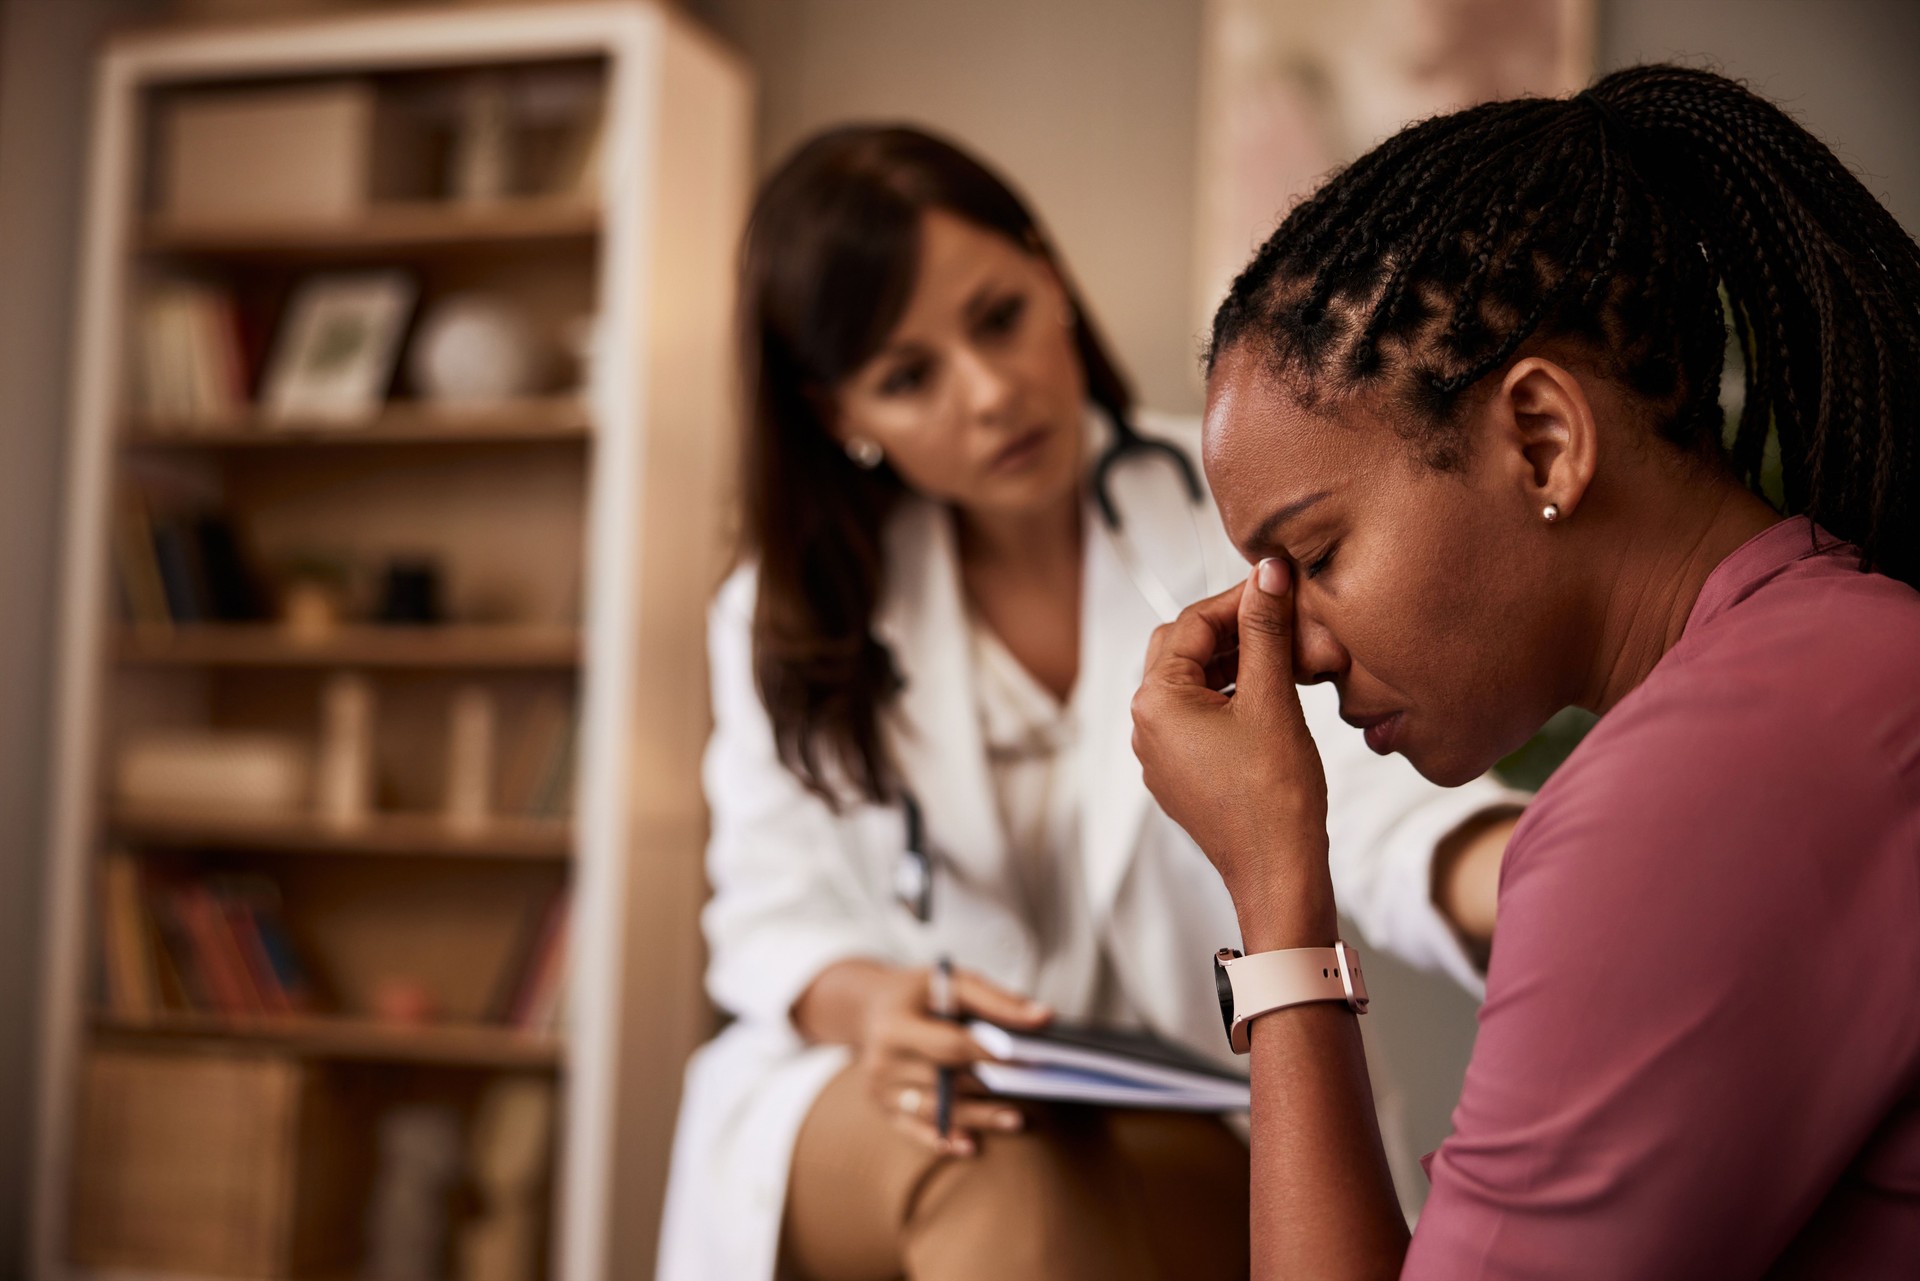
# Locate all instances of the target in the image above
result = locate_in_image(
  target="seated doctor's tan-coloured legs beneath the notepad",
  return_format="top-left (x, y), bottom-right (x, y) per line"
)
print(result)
top-left (781, 1072), bottom-right (1248, 1281)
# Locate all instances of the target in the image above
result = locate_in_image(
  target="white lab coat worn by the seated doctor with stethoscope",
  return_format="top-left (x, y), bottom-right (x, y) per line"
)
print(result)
top-left (657, 415), bottom-right (1513, 1281)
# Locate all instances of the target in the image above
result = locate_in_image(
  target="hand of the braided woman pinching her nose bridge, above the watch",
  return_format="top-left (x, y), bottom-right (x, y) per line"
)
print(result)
top-left (1133, 559), bottom-right (1336, 953)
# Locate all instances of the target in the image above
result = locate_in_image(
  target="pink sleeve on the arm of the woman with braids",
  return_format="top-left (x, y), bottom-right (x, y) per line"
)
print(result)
top-left (1404, 701), bottom-right (1920, 1279)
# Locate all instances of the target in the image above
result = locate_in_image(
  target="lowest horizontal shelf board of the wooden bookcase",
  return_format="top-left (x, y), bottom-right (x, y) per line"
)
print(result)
top-left (94, 1012), bottom-right (566, 1070)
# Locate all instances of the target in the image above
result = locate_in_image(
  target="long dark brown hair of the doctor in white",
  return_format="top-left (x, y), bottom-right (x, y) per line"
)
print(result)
top-left (739, 125), bottom-right (1133, 805)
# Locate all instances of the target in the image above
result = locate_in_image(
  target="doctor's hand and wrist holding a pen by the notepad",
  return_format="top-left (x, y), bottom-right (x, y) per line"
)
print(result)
top-left (793, 960), bottom-right (1054, 1156)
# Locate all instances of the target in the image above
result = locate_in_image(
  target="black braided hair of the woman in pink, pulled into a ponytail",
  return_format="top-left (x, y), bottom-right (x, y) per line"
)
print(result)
top-left (1208, 65), bottom-right (1920, 584)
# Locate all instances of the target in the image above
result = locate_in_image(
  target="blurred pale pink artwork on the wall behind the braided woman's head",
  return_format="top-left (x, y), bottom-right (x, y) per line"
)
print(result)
top-left (1194, 0), bottom-right (1596, 332)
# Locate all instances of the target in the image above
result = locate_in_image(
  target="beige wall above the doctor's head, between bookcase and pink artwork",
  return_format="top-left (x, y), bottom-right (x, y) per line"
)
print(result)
top-left (687, 0), bottom-right (1200, 409)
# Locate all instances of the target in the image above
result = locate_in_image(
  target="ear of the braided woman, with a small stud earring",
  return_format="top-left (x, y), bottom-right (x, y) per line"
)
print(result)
top-left (1488, 355), bottom-right (1599, 519)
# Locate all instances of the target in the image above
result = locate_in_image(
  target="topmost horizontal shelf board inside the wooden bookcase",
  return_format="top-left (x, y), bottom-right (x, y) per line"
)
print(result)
top-left (140, 198), bottom-right (601, 259)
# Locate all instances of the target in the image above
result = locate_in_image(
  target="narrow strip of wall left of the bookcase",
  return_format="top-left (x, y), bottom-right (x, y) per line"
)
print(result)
top-left (0, 0), bottom-right (163, 1275)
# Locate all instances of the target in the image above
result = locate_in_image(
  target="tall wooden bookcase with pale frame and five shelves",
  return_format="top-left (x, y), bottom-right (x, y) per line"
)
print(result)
top-left (43, 10), bottom-right (753, 1281)
